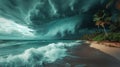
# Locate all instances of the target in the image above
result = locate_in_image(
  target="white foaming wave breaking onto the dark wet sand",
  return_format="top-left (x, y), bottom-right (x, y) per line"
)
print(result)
top-left (0, 43), bottom-right (78, 67)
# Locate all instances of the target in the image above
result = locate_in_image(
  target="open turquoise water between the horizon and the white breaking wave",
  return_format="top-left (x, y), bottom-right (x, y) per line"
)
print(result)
top-left (0, 40), bottom-right (78, 56)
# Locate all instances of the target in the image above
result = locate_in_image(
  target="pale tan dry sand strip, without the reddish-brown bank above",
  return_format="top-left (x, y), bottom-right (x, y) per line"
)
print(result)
top-left (87, 41), bottom-right (120, 60)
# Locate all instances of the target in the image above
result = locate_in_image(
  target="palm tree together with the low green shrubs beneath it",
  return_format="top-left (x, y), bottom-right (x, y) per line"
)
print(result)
top-left (81, 0), bottom-right (120, 42)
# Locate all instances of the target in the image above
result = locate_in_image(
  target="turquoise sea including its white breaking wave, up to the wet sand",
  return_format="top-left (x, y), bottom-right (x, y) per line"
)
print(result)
top-left (0, 40), bottom-right (83, 67)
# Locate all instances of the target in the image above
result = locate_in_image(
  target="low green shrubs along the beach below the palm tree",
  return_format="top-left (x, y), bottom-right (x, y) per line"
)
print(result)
top-left (80, 32), bottom-right (120, 42)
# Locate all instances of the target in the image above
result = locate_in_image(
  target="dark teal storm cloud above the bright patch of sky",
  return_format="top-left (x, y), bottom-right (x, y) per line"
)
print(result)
top-left (0, 0), bottom-right (109, 38)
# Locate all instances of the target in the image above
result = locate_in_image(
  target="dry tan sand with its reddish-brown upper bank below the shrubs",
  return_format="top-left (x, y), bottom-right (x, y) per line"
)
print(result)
top-left (86, 41), bottom-right (120, 60)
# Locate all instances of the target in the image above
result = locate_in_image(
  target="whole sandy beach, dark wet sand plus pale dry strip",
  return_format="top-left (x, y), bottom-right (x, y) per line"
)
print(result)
top-left (59, 43), bottom-right (120, 67)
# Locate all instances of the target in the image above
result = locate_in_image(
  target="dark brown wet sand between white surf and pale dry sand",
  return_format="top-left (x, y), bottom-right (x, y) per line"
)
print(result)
top-left (46, 43), bottom-right (120, 67)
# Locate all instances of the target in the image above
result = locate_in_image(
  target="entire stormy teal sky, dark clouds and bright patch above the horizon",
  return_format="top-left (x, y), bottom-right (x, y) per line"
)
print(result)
top-left (0, 0), bottom-right (107, 39)
